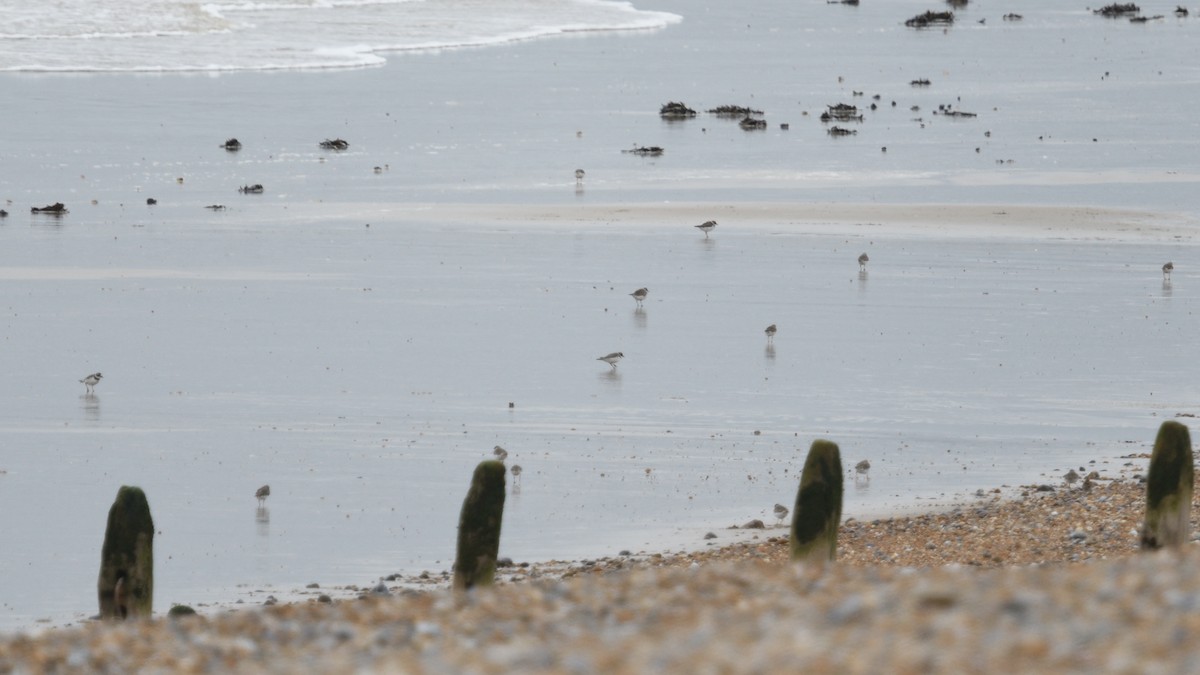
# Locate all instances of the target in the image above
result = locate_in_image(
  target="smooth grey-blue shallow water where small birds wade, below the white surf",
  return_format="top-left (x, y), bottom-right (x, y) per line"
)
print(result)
top-left (0, 2), bottom-right (1200, 628)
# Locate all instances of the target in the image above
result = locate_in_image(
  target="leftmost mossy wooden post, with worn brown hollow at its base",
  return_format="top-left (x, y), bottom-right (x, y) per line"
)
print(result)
top-left (97, 485), bottom-right (154, 619)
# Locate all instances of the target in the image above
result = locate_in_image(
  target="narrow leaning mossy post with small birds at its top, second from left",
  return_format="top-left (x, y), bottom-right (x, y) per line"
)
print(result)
top-left (454, 460), bottom-right (508, 591)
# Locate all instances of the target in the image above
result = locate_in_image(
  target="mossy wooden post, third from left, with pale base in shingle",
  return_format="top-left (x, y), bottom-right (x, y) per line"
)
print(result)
top-left (792, 440), bottom-right (842, 565)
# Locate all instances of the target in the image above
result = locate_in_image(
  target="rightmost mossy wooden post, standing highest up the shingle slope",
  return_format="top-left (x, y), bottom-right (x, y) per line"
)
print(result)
top-left (1141, 419), bottom-right (1195, 549)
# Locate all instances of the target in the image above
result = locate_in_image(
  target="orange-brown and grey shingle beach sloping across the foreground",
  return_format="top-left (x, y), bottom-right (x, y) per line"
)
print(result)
top-left (0, 468), bottom-right (1200, 673)
